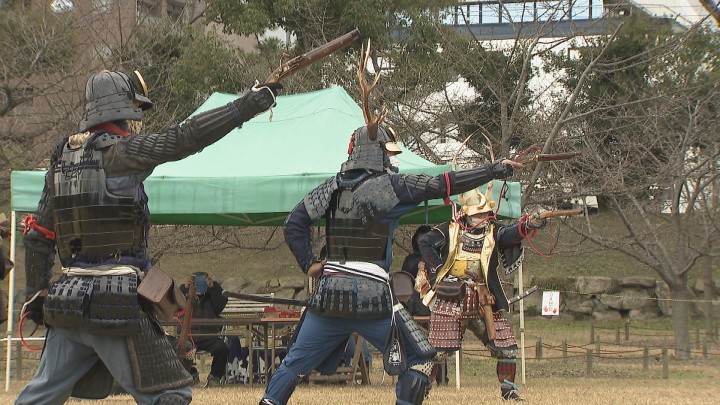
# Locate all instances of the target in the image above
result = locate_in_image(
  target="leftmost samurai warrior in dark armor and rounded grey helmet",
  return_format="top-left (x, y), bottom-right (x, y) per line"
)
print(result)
top-left (15, 70), bottom-right (281, 405)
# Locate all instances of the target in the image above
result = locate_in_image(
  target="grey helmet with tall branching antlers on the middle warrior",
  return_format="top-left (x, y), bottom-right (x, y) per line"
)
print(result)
top-left (341, 40), bottom-right (402, 172)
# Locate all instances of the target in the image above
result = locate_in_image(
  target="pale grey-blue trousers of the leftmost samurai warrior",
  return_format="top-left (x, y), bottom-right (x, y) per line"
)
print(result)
top-left (15, 327), bottom-right (192, 405)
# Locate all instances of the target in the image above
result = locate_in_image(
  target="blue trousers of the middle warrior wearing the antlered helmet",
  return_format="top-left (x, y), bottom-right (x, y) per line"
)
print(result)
top-left (263, 312), bottom-right (431, 405)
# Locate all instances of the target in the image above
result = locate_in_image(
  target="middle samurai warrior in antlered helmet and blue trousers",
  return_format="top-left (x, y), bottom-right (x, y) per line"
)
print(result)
top-left (260, 39), bottom-right (524, 405)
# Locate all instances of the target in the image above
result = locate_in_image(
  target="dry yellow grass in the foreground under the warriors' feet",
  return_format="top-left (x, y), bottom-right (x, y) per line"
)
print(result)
top-left (0, 364), bottom-right (720, 405)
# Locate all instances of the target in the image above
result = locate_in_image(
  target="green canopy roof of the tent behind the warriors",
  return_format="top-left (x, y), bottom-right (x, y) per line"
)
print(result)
top-left (11, 87), bottom-right (520, 225)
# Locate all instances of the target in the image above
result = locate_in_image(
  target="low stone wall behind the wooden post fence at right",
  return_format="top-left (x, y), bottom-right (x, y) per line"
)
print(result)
top-left (516, 276), bottom-right (720, 320)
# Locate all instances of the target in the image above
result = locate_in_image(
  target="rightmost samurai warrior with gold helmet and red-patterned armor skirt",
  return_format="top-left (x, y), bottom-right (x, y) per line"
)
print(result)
top-left (416, 189), bottom-right (545, 400)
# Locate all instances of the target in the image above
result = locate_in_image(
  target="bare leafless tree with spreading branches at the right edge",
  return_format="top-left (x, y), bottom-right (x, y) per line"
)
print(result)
top-left (544, 15), bottom-right (720, 358)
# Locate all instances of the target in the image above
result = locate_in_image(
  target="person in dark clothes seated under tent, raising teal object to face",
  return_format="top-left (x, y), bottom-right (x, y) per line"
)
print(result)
top-left (180, 272), bottom-right (230, 387)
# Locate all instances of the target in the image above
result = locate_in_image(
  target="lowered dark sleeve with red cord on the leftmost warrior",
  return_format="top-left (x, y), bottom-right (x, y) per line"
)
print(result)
top-left (23, 174), bottom-right (55, 297)
